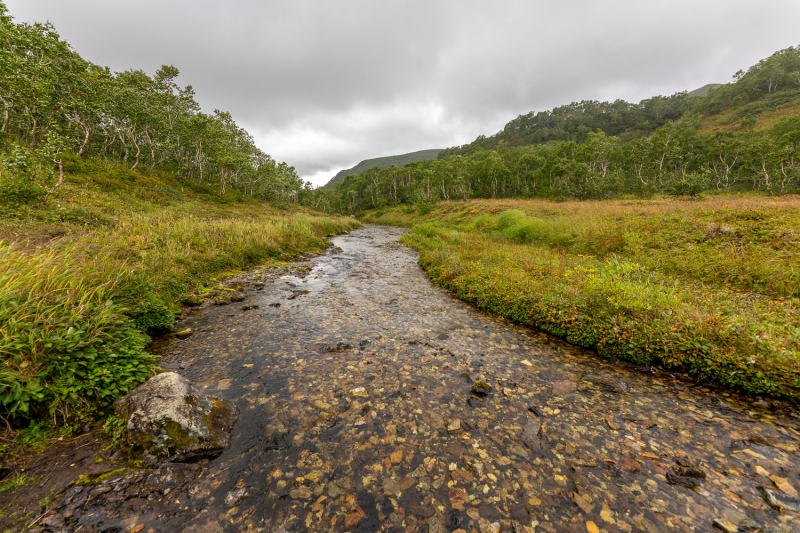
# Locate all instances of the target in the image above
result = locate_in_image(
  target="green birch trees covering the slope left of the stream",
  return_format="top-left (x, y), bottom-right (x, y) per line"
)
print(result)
top-left (0, 2), bottom-right (305, 203)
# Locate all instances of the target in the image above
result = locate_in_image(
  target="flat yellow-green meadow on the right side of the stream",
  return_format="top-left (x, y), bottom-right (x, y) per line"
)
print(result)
top-left (362, 195), bottom-right (800, 401)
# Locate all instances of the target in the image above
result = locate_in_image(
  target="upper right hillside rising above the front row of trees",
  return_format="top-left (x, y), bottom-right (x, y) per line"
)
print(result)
top-left (439, 47), bottom-right (800, 159)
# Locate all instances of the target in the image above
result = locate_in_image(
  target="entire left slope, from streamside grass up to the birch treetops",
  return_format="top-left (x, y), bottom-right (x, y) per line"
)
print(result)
top-left (0, 2), bottom-right (358, 451)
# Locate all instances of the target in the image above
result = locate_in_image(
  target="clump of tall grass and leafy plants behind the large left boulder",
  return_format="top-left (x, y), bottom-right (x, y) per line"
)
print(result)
top-left (0, 245), bottom-right (154, 426)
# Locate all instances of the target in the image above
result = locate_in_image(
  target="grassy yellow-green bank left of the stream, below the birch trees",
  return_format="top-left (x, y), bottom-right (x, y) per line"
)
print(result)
top-left (0, 164), bottom-right (358, 436)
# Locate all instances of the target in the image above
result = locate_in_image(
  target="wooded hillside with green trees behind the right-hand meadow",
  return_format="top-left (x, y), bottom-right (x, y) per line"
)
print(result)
top-left (320, 47), bottom-right (800, 212)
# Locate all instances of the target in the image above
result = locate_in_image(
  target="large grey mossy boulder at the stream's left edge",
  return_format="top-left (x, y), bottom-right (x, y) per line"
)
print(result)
top-left (115, 372), bottom-right (238, 461)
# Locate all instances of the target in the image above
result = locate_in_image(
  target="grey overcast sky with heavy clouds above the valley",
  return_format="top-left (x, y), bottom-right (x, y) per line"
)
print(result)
top-left (5, 0), bottom-right (800, 185)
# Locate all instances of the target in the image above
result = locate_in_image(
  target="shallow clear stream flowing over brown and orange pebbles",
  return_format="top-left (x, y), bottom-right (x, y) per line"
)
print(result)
top-left (39, 226), bottom-right (800, 533)
